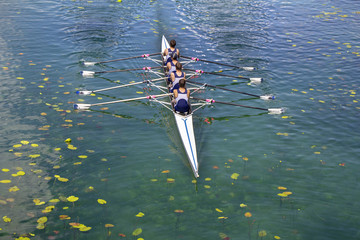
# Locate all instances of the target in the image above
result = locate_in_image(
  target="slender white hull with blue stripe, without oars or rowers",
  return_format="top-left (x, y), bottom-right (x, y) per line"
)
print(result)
top-left (161, 36), bottom-right (199, 178)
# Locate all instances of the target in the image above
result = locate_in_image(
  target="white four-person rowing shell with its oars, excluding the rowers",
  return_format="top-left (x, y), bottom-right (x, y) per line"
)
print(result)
top-left (74, 36), bottom-right (283, 178)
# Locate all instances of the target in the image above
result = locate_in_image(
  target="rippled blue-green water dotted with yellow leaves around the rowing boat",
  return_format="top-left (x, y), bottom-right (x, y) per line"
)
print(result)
top-left (0, 0), bottom-right (360, 240)
